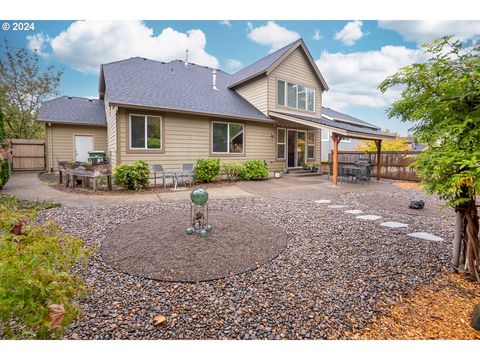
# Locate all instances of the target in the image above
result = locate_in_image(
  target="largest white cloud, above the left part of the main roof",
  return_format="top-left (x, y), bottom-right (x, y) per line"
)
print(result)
top-left (31, 20), bottom-right (219, 73)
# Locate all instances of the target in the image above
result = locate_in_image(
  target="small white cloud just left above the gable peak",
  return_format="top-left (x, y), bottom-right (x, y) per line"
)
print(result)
top-left (247, 21), bottom-right (300, 52)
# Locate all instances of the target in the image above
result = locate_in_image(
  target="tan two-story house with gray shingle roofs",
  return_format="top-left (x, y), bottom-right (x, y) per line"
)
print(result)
top-left (39, 39), bottom-right (390, 174)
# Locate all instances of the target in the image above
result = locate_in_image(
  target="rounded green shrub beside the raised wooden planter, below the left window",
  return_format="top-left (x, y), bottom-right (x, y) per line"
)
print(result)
top-left (113, 160), bottom-right (150, 191)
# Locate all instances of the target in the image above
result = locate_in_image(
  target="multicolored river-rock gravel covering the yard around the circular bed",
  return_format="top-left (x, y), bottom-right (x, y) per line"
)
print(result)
top-left (40, 189), bottom-right (454, 339)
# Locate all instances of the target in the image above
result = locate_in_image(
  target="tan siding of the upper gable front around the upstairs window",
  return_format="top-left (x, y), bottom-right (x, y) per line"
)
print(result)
top-left (268, 48), bottom-right (322, 116)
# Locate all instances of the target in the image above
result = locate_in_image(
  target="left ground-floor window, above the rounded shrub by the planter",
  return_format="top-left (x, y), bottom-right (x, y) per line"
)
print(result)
top-left (129, 114), bottom-right (162, 150)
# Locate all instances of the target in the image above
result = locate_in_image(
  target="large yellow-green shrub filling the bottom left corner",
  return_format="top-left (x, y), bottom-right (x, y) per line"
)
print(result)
top-left (0, 205), bottom-right (90, 339)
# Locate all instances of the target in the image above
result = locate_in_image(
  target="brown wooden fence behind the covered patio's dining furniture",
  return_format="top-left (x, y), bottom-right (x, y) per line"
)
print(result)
top-left (322, 151), bottom-right (421, 181)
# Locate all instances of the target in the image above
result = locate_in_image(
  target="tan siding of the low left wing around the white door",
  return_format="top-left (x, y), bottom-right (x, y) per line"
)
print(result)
top-left (46, 124), bottom-right (107, 170)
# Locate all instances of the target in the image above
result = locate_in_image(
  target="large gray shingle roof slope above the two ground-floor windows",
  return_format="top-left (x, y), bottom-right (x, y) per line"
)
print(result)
top-left (102, 57), bottom-right (270, 121)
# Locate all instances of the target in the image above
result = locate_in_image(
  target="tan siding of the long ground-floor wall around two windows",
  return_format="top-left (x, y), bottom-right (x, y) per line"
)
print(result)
top-left (117, 108), bottom-right (283, 169)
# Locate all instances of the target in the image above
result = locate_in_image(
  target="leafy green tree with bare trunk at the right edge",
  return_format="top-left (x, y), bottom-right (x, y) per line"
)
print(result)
top-left (379, 37), bottom-right (480, 282)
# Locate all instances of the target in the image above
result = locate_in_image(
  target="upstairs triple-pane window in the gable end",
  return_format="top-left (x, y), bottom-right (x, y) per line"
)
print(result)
top-left (277, 80), bottom-right (315, 111)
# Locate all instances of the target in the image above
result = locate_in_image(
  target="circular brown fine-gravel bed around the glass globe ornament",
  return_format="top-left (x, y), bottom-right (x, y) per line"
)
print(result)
top-left (101, 211), bottom-right (287, 282)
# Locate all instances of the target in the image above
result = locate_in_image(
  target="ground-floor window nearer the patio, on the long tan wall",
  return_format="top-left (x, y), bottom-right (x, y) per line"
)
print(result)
top-left (212, 122), bottom-right (244, 154)
